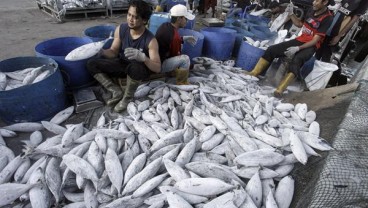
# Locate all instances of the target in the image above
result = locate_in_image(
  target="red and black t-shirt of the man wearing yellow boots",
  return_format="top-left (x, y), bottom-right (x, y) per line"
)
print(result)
top-left (296, 10), bottom-right (332, 48)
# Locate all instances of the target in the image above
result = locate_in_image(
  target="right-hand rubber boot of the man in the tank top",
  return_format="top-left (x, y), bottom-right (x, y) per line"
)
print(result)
top-left (114, 76), bottom-right (141, 113)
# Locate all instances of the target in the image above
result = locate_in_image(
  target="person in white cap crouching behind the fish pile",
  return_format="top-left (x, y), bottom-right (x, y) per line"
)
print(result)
top-left (156, 4), bottom-right (197, 85)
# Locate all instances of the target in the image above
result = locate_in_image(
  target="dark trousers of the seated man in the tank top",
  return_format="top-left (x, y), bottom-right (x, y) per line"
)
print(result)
top-left (87, 58), bottom-right (150, 80)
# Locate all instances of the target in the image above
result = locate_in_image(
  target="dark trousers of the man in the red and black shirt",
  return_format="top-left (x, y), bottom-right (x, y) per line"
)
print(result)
top-left (262, 39), bottom-right (316, 76)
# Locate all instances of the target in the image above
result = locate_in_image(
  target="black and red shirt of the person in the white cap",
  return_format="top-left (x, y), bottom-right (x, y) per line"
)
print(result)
top-left (156, 22), bottom-right (183, 61)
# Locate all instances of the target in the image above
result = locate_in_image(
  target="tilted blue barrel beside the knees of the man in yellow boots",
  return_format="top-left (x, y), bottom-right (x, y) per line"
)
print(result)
top-left (235, 41), bottom-right (265, 71)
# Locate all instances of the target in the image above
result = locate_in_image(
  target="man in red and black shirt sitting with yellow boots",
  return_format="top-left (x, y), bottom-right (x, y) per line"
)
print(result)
top-left (250, 0), bottom-right (332, 97)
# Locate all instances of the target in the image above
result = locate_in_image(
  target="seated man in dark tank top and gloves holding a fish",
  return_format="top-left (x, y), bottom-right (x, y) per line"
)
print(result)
top-left (87, 0), bottom-right (161, 113)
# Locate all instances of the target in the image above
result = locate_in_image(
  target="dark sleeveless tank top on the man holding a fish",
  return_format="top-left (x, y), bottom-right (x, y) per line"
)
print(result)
top-left (119, 23), bottom-right (155, 60)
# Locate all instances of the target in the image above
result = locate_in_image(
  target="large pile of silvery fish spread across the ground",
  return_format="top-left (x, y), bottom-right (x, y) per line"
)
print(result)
top-left (0, 58), bottom-right (332, 208)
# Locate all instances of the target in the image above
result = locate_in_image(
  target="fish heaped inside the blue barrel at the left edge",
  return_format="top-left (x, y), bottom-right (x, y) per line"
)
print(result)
top-left (0, 65), bottom-right (55, 91)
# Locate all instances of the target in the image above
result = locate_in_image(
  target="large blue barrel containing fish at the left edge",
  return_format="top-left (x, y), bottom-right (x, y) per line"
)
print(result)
top-left (0, 57), bottom-right (67, 123)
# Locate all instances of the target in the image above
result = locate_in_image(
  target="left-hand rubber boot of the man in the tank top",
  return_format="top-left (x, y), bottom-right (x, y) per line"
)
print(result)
top-left (93, 73), bottom-right (123, 106)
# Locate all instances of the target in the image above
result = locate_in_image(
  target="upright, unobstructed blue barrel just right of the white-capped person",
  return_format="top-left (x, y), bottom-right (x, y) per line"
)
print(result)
top-left (201, 27), bottom-right (236, 61)
